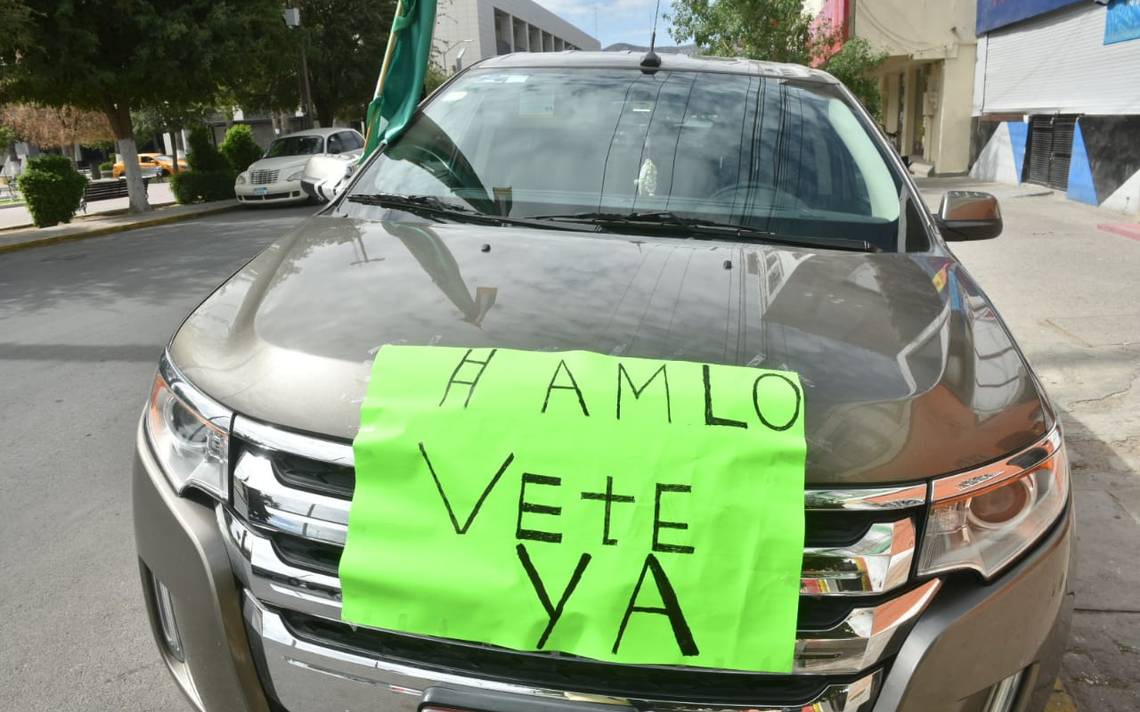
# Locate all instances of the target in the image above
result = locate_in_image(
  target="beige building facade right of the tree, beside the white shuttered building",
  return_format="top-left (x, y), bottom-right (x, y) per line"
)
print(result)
top-left (806, 0), bottom-right (976, 174)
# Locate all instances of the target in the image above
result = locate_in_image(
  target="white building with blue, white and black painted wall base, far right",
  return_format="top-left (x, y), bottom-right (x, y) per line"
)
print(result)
top-left (971, 0), bottom-right (1140, 214)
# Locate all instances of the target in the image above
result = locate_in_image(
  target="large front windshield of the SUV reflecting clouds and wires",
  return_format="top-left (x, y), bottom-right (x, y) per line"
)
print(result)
top-left (343, 68), bottom-right (926, 251)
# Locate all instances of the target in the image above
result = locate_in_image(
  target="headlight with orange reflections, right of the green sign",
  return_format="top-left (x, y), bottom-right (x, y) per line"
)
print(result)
top-left (919, 428), bottom-right (1069, 579)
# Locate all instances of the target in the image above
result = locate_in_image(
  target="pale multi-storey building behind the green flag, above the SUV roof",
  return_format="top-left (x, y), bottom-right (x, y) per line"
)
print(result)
top-left (432, 0), bottom-right (602, 72)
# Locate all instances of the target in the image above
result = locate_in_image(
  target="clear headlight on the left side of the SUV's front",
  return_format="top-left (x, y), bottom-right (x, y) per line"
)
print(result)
top-left (146, 354), bottom-right (234, 500)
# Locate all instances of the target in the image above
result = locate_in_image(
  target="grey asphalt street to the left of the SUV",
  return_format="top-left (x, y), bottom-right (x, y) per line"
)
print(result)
top-left (0, 202), bottom-right (312, 712)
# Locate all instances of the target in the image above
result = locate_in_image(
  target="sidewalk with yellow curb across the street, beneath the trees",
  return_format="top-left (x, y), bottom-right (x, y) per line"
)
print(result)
top-left (0, 197), bottom-right (238, 254)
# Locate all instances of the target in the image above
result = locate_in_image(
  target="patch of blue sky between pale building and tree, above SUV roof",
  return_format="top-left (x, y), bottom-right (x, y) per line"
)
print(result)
top-left (535, 0), bottom-right (675, 48)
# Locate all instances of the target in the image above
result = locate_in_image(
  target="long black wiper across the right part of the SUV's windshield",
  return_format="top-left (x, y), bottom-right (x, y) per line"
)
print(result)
top-left (534, 211), bottom-right (882, 252)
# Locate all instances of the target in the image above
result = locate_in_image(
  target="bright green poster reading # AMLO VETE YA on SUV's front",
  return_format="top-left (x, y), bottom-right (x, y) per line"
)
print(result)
top-left (340, 346), bottom-right (805, 672)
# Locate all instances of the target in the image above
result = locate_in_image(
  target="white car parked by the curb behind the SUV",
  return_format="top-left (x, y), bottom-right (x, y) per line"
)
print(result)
top-left (234, 126), bottom-right (364, 204)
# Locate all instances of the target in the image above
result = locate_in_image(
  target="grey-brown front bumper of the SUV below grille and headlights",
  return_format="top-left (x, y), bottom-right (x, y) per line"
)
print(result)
top-left (133, 419), bottom-right (1073, 712)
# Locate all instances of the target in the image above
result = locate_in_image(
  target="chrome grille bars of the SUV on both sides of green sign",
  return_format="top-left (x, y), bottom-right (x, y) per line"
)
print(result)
top-left (217, 417), bottom-right (941, 711)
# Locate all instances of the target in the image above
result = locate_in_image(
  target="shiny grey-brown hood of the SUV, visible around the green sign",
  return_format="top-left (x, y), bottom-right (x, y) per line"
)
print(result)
top-left (171, 216), bottom-right (1053, 484)
